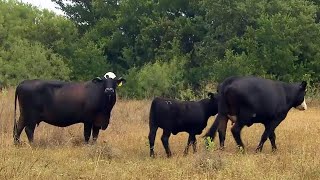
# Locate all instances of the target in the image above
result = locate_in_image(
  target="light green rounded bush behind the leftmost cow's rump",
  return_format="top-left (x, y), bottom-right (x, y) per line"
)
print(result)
top-left (0, 39), bottom-right (70, 86)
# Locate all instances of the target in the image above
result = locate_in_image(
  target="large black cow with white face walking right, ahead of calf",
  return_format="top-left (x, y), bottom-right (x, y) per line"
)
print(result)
top-left (205, 76), bottom-right (307, 152)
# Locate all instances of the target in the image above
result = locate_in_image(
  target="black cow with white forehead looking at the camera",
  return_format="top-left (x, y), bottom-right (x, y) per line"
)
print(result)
top-left (13, 73), bottom-right (125, 144)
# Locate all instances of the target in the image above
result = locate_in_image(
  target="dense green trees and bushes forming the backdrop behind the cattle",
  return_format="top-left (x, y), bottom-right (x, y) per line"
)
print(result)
top-left (0, 0), bottom-right (320, 98)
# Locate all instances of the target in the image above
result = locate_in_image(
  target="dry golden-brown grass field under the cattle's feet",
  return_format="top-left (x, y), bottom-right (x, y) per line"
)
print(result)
top-left (0, 90), bottom-right (320, 180)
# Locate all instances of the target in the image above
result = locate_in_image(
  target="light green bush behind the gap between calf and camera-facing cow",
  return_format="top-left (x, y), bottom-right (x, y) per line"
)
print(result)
top-left (120, 57), bottom-right (185, 99)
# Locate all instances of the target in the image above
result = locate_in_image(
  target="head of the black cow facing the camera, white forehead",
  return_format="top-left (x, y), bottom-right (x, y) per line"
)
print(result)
top-left (92, 76), bottom-right (126, 95)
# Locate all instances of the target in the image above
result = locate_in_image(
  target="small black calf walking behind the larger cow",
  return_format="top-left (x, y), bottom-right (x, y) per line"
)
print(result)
top-left (148, 93), bottom-right (218, 157)
